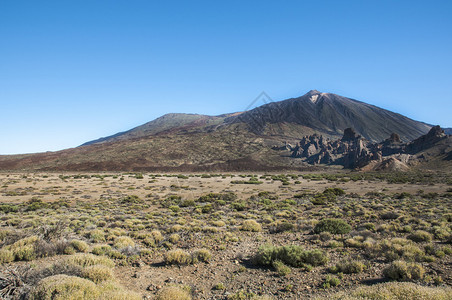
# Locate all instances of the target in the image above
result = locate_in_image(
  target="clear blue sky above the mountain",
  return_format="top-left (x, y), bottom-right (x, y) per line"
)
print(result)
top-left (0, 0), bottom-right (452, 154)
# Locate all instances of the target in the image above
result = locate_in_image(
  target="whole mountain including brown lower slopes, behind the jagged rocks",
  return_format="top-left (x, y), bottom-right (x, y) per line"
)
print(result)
top-left (0, 91), bottom-right (446, 171)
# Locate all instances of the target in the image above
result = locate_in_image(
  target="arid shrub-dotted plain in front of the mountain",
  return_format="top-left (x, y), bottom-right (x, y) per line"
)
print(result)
top-left (0, 173), bottom-right (452, 299)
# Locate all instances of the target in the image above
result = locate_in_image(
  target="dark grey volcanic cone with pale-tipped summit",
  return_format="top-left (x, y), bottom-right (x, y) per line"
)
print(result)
top-left (227, 90), bottom-right (432, 142)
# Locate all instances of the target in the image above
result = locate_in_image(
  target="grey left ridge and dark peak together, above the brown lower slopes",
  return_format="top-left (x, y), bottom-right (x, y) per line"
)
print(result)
top-left (81, 90), bottom-right (438, 146)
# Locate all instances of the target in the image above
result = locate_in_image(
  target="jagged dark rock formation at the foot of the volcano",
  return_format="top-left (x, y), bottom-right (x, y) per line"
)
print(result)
top-left (292, 126), bottom-right (447, 170)
